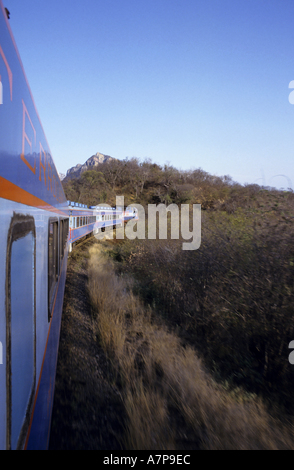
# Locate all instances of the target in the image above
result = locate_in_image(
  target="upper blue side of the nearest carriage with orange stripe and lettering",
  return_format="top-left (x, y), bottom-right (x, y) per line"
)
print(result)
top-left (0, 0), bottom-right (67, 210)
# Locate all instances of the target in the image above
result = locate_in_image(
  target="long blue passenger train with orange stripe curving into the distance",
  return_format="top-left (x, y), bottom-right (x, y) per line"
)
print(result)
top-left (0, 0), bottom-right (136, 450)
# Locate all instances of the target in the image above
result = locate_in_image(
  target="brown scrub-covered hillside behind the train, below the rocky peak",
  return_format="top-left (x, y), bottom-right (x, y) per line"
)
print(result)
top-left (63, 158), bottom-right (240, 209)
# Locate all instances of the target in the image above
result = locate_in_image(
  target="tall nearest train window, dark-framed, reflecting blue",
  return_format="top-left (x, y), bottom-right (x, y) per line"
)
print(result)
top-left (6, 215), bottom-right (36, 450)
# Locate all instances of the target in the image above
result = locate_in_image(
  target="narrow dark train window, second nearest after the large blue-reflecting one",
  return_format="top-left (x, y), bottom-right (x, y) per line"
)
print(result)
top-left (48, 219), bottom-right (58, 321)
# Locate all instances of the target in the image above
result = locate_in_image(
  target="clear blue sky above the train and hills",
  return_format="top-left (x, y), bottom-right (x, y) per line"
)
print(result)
top-left (3, 0), bottom-right (294, 189)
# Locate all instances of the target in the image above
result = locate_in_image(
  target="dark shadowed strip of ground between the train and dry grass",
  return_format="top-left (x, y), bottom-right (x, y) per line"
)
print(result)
top-left (49, 238), bottom-right (123, 450)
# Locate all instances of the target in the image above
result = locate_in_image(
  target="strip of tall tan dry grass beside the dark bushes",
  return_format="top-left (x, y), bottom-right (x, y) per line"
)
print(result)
top-left (88, 244), bottom-right (294, 450)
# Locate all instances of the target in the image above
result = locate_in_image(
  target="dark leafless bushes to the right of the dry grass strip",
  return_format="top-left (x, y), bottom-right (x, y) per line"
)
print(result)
top-left (108, 202), bottom-right (294, 412)
